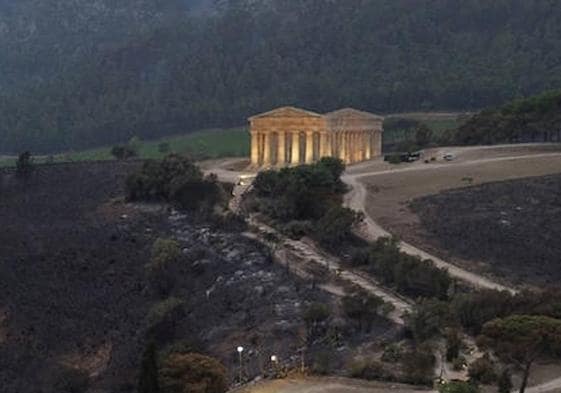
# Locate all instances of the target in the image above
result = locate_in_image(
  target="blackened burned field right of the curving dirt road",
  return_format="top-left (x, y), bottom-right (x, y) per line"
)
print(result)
top-left (410, 175), bottom-right (561, 285)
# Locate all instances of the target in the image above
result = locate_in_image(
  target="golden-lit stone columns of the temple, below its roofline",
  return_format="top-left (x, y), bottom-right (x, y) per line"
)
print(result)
top-left (251, 131), bottom-right (381, 166)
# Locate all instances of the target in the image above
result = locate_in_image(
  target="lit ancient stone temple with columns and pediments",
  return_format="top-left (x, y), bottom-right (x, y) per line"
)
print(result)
top-left (249, 107), bottom-right (384, 167)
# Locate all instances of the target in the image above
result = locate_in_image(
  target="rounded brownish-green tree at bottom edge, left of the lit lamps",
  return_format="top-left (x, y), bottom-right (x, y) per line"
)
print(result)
top-left (160, 353), bottom-right (228, 393)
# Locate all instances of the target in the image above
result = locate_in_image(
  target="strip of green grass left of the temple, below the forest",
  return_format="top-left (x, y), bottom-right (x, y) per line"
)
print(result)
top-left (0, 127), bottom-right (249, 167)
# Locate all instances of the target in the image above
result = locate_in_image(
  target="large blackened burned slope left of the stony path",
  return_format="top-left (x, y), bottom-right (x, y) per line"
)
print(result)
top-left (0, 162), bottom-right (394, 393)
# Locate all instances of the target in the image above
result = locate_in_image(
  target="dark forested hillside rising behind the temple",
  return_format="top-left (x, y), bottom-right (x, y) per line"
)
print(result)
top-left (0, 0), bottom-right (561, 152)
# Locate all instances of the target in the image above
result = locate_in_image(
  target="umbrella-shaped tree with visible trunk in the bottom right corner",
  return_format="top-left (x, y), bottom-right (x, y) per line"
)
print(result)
top-left (478, 315), bottom-right (561, 393)
